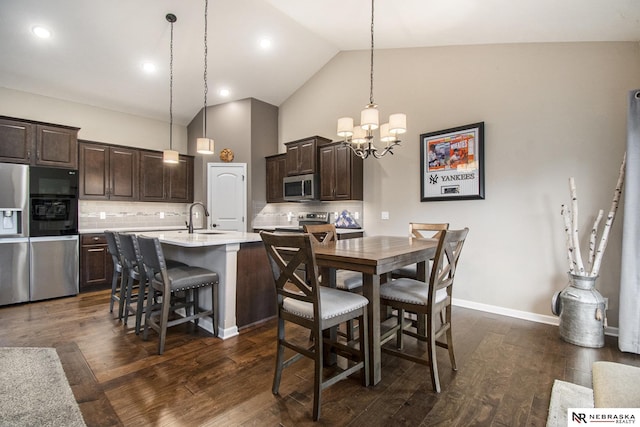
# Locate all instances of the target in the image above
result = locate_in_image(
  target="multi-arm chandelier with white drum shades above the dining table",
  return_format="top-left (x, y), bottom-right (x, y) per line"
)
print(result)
top-left (338, 0), bottom-right (407, 159)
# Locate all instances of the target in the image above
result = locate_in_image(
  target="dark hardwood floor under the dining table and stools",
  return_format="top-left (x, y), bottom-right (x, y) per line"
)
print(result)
top-left (0, 291), bottom-right (640, 426)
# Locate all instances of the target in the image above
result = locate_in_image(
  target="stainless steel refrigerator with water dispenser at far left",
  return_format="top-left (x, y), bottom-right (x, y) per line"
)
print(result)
top-left (0, 163), bottom-right (79, 306)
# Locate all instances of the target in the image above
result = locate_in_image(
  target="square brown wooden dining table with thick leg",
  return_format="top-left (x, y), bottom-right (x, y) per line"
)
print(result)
top-left (315, 236), bottom-right (437, 385)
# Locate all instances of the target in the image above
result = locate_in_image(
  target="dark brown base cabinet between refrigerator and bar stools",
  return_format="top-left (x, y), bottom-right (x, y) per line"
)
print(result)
top-left (80, 234), bottom-right (113, 292)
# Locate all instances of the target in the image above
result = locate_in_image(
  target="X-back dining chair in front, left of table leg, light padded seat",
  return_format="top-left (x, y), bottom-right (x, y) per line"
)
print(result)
top-left (260, 231), bottom-right (369, 421)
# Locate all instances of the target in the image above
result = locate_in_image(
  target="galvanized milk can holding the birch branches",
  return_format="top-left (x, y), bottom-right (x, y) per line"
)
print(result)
top-left (551, 273), bottom-right (606, 348)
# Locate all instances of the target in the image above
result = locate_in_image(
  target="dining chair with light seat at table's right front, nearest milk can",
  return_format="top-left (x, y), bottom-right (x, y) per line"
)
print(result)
top-left (380, 228), bottom-right (469, 393)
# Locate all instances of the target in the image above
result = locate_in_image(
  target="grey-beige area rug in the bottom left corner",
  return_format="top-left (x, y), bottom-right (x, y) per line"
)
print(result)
top-left (0, 347), bottom-right (86, 427)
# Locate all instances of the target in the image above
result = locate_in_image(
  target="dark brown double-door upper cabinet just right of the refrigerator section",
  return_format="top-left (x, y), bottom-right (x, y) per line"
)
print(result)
top-left (78, 141), bottom-right (139, 201)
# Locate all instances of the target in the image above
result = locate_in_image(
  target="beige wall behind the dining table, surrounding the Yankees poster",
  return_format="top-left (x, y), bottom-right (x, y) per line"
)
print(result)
top-left (279, 43), bottom-right (640, 326)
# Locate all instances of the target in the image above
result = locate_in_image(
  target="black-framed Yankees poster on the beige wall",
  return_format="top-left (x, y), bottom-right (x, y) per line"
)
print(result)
top-left (420, 122), bottom-right (484, 202)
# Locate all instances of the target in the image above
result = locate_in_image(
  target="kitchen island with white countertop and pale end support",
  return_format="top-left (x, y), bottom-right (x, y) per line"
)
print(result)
top-left (136, 230), bottom-right (266, 339)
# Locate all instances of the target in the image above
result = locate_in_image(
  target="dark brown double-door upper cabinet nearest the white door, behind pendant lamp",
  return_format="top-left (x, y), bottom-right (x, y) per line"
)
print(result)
top-left (140, 150), bottom-right (193, 203)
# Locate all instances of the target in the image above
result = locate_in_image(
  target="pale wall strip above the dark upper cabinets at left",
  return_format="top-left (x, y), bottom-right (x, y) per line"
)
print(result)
top-left (0, 87), bottom-right (187, 154)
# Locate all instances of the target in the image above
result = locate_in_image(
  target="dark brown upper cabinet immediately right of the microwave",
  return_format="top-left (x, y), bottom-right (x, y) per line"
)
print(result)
top-left (318, 142), bottom-right (363, 200)
